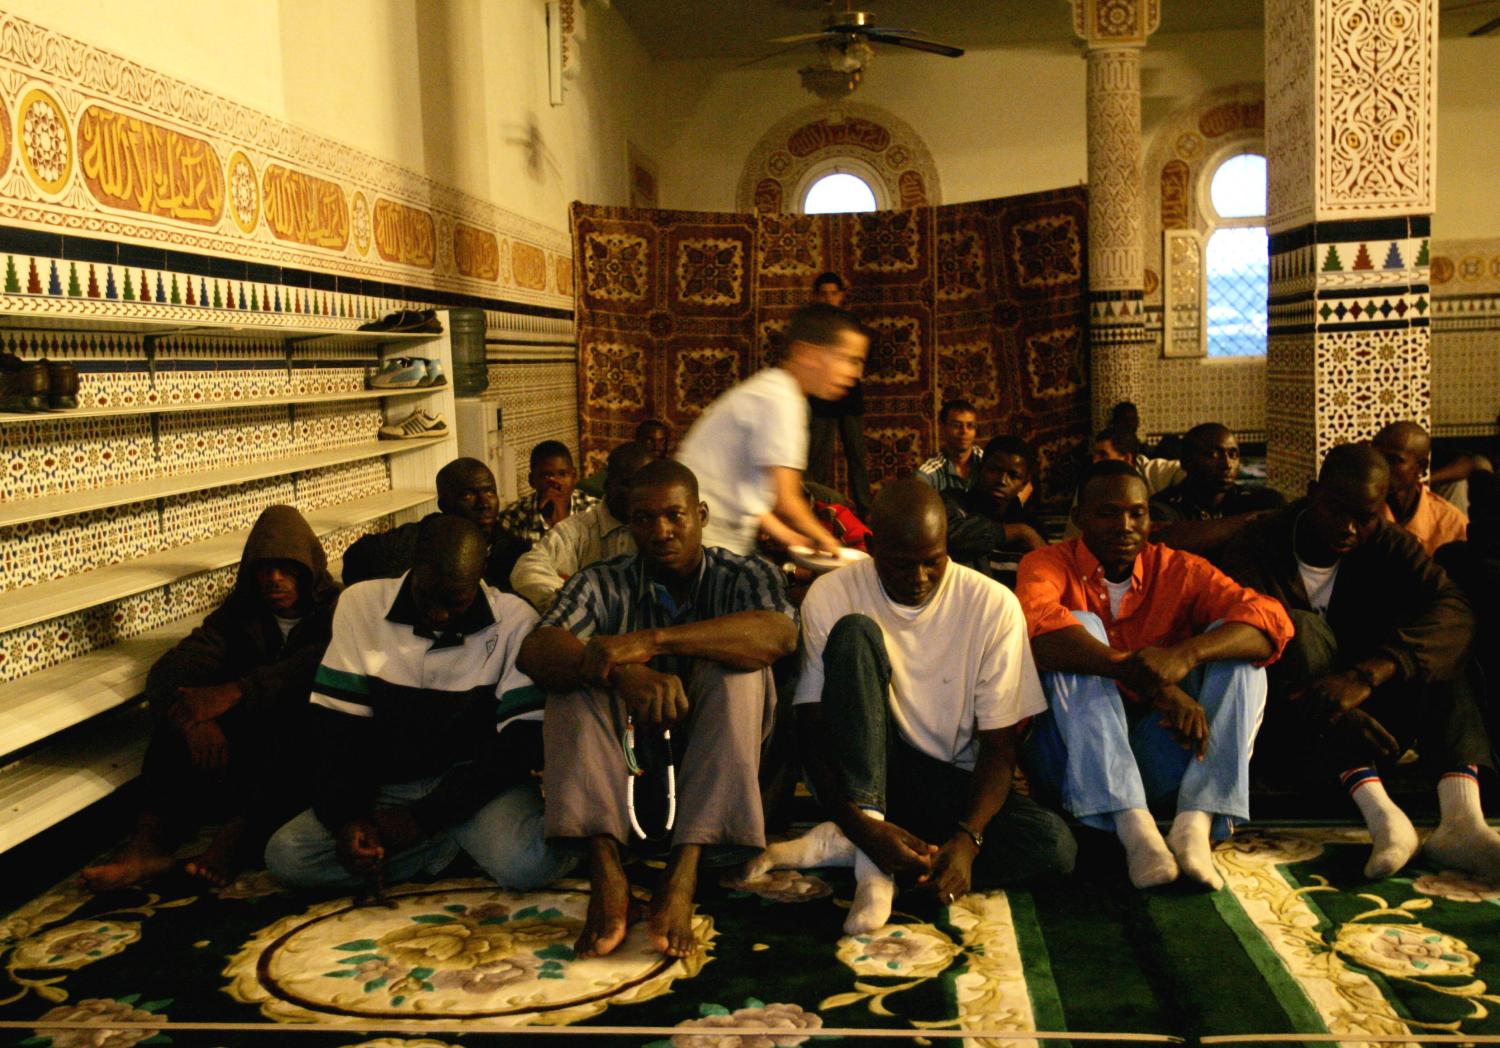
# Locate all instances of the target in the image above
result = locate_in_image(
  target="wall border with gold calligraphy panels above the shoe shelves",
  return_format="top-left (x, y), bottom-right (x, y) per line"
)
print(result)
top-left (0, 15), bottom-right (572, 309)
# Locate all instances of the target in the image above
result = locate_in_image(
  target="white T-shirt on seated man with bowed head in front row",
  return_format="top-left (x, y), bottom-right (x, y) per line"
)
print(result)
top-left (794, 561), bottom-right (1047, 771)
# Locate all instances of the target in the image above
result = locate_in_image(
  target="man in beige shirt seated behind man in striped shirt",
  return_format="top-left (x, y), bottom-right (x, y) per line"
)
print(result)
top-left (510, 441), bottom-right (651, 615)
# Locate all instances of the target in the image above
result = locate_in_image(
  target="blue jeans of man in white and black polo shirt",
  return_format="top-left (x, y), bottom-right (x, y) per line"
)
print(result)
top-left (266, 777), bottom-right (578, 889)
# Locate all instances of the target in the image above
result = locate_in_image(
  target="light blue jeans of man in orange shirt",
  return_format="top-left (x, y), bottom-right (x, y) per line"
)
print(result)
top-left (1025, 612), bottom-right (1266, 840)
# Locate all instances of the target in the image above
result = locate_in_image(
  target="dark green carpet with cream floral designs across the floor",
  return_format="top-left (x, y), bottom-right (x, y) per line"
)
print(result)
top-left (0, 828), bottom-right (1500, 1048)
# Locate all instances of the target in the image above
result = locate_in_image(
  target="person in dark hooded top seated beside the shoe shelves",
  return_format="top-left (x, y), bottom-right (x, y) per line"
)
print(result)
top-left (83, 505), bottom-right (339, 892)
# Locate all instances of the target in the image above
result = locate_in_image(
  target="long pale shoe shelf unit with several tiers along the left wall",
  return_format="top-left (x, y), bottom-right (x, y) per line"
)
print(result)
top-left (0, 307), bottom-right (458, 852)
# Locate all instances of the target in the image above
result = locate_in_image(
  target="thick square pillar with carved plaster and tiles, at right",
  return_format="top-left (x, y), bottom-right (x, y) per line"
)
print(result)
top-left (1266, 0), bottom-right (1439, 495)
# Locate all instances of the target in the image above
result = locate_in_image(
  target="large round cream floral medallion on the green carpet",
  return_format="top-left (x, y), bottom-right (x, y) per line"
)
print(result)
top-left (224, 880), bottom-right (716, 1026)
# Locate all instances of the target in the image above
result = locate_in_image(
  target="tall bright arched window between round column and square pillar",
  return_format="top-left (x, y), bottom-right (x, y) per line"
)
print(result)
top-left (1203, 153), bottom-right (1271, 357)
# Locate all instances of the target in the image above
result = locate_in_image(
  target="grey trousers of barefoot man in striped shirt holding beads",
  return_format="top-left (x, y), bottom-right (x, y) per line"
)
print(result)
top-left (543, 660), bottom-right (776, 852)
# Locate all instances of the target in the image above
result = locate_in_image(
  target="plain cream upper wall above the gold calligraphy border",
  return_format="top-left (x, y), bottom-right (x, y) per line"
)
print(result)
top-left (6, 0), bottom-right (653, 229)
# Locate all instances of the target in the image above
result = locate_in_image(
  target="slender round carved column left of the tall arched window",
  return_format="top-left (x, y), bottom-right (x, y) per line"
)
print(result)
top-left (1073, 0), bottom-right (1160, 429)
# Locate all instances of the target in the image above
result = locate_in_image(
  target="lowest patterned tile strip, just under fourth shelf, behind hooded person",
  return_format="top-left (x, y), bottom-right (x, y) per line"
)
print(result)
top-left (0, 517), bottom-right (392, 682)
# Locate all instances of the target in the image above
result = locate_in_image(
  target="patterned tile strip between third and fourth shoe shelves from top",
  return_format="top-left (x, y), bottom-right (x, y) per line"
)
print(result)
top-left (0, 459), bottom-right (390, 592)
